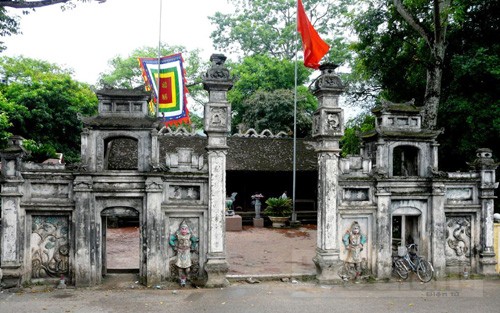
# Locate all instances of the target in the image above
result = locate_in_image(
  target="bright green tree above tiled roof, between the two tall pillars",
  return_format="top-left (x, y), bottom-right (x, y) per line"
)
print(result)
top-left (228, 55), bottom-right (317, 132)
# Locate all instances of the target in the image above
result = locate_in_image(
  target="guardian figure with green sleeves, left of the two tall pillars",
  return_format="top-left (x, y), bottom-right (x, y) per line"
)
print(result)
top-left (169, 220), bottom-right (199, 287)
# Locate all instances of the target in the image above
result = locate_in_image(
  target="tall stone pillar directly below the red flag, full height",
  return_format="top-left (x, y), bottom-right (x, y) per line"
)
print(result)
top-left (312, 64), bottom-right (344, 283)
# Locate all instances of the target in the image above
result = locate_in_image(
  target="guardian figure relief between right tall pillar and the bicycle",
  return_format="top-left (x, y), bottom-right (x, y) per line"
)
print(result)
top-left (340, 221), bottom-right (366, 280)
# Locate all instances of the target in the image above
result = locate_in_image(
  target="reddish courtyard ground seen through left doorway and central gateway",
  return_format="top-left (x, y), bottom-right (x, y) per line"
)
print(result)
top-left (106, 225), bottom-right (316, 275)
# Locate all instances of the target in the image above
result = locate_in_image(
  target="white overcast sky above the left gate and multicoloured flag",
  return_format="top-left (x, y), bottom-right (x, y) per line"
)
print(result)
top-left (3, 0), bottom-right (231, 84)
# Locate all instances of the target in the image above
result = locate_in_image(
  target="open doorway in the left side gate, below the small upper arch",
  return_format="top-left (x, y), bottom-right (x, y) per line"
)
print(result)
top-left (101, 208), bottom-right (141, 276)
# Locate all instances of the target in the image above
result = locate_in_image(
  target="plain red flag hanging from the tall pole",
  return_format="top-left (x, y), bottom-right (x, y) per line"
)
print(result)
top-left (297, 0), bottom-right (330, 69)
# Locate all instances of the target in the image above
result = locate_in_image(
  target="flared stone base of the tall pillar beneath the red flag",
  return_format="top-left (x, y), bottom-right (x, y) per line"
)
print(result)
top-left (313, 251), bottom-right (343, 285)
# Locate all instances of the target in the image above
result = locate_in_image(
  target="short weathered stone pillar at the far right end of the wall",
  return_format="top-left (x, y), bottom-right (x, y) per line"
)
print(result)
top-left (474, 149), bottom-right (498, 275)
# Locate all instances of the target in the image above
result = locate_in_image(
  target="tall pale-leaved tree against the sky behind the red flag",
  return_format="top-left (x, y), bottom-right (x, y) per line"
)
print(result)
top-left (209, 0), bottom-right (349, 63)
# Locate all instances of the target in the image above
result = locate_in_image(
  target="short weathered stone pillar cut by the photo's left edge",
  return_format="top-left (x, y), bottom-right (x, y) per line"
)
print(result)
top-left (0, 136), bottom-right (27, 286)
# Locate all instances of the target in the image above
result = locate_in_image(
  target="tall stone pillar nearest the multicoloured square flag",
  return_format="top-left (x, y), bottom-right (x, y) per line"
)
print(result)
top-left (203, 54), bottom-right (233, 287)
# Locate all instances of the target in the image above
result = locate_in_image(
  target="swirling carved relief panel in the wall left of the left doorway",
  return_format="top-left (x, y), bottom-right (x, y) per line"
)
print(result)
top-left (31, 215), bottom-right (69, 278)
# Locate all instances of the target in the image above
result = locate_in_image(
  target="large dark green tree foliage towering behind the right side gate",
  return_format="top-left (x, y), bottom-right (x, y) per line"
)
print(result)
top-left (352, 0), bottom-right (500, 170)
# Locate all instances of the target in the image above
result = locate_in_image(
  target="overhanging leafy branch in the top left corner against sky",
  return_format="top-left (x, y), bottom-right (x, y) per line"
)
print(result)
top-left (0, 0), bottom-right (106, 52)
